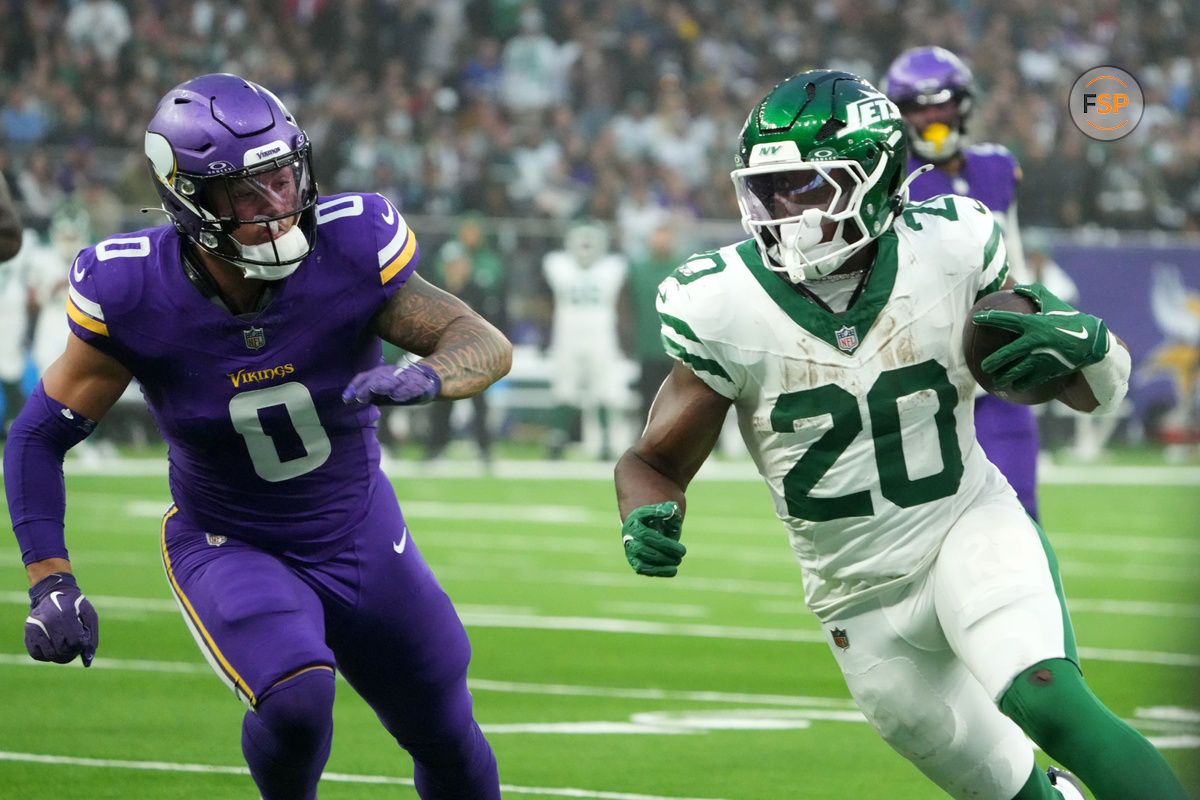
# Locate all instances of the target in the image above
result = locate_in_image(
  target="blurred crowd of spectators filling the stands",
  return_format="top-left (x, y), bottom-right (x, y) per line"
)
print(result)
top-left (0, 0), bottom-right (1200, 241)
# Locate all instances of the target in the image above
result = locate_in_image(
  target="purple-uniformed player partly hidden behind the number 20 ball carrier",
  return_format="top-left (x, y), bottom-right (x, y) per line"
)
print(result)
top-left (882, 47), bottom-right (1041, 519)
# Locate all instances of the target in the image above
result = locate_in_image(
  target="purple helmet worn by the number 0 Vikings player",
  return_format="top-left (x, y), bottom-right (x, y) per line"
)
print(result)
top-left (145, 74), bottom-right (317, 281)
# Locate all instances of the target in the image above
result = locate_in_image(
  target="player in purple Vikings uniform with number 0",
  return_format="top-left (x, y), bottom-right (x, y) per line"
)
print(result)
top-left (4, 74), bottom-right (511, 800)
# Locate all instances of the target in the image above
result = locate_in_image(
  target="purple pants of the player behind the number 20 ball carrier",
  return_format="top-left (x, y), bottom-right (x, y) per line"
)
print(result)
top-left (976, 395), bottom-right (1038, 521)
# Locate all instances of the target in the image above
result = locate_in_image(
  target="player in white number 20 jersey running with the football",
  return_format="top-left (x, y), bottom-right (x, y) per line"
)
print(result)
top-left (616, 70), bottom-right (1187, 800)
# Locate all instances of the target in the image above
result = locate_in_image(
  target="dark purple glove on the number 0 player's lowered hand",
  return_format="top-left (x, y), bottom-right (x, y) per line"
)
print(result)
top-left (25, 572), bottom-right (100, 667)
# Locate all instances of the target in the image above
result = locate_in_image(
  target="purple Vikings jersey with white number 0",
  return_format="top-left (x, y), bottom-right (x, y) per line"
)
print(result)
top-left (67, 194), bottom-right (419, 560)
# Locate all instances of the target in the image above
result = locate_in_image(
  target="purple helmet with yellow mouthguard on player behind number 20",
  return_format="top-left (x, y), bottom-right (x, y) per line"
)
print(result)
top-left (882, 47), bottom-right (974, 163)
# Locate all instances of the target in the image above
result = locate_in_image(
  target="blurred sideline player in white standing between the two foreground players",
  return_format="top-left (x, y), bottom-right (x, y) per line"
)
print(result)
top-left (542, 222), bottom-right (631, 458)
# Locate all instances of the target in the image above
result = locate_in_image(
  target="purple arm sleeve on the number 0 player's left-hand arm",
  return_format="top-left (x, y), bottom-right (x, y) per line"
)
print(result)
top-left (4, 383), bottom-right (96, 564)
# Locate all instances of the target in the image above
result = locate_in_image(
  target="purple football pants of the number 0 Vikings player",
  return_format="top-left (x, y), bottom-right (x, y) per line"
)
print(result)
top-left (162, 472), bottom-right (500, 800)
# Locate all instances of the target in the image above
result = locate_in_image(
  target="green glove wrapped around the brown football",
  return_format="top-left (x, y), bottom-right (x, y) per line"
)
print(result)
top-left (971, 283), bottom-right (1109, 392)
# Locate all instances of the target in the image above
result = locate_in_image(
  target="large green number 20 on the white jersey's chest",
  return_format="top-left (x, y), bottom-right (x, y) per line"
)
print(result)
top-left (770, 361), bottom-right (962, 522)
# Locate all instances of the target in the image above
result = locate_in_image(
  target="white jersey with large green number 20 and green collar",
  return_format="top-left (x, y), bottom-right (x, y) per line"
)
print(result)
top-left (658, 194), bottom-right (1012, 619)
